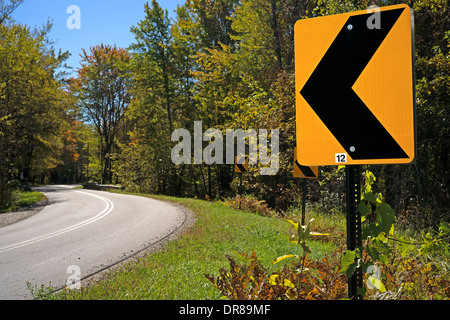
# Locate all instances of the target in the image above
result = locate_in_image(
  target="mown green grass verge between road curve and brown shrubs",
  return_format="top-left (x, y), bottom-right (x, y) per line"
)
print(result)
top-left (51, 192), bottom-right (337, 300)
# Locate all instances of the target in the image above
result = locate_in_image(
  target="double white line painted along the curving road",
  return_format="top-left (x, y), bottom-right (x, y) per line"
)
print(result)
top-left (0, 191), bottom-right (114, 253)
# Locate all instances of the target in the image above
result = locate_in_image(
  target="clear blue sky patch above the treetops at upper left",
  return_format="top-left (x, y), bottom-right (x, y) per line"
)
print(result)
top-left (12, 0), bottom-right (186, 75)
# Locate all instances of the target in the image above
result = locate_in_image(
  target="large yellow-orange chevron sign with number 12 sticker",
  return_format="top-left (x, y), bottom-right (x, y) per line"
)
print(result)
top-left (294, 4), bottom-right (416, 166)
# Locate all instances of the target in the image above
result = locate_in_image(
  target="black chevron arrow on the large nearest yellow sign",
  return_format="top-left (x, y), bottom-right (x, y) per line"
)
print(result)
top-left (300, 8), bottom-right (408, 160)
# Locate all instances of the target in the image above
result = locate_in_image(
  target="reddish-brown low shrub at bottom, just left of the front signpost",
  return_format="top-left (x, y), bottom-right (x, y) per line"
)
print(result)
top-left (205, 251), bottom-right (347, 300)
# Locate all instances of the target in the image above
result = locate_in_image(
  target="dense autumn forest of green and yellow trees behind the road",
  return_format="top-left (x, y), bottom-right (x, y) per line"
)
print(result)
top-left (0, 0), bottom-right (450, 229)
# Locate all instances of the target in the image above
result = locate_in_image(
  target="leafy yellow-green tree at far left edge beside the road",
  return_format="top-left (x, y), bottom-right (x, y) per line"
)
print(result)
top-left (0, 18), bottom-right (68, 206)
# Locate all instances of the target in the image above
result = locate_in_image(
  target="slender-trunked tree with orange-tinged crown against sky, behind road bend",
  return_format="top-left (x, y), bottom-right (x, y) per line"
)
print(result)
top-left (70, 44), bottom-right (131, 183)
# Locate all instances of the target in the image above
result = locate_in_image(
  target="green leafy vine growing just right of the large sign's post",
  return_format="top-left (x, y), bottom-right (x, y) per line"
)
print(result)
top-left (341, 170), bottom-right (450, 297)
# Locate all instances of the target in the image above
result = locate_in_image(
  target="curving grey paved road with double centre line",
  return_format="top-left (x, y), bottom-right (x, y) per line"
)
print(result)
top-left (0, 185), bottom-right (187, 300)
